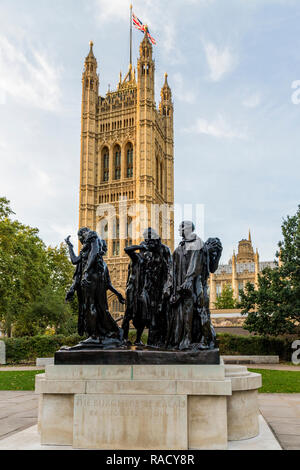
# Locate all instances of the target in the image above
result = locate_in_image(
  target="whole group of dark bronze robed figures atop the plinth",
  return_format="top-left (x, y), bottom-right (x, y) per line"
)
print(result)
top-left (65, 221), bottom-right (222, 351)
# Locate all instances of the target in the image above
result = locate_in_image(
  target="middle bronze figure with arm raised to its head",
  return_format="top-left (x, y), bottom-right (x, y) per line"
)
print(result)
top-left (122, 227), bottom-right (172, 347)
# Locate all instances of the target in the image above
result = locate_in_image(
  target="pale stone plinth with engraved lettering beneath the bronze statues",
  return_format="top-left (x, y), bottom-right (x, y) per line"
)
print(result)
top-left (36, 364), bottom-right (260, 450)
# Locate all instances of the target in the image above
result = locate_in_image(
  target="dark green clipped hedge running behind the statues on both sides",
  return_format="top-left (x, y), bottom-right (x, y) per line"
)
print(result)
top-left (0, 331), bottom-right (298, 363)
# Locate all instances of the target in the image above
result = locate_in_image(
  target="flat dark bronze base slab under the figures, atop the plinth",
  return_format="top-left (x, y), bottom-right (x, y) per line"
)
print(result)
top-left (54, 346), bottom-right (220, 365)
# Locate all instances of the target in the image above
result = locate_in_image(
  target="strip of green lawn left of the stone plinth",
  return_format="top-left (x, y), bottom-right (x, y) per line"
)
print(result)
top-left (0, 370), bottom-right (44, 390)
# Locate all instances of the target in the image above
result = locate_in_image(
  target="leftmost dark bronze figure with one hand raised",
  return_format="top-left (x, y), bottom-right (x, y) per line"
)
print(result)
top-left (65, 227), bottom-right (125, 347)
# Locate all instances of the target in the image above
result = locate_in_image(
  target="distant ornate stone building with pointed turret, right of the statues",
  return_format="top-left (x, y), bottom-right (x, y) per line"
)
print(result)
top-left (210, 230), bottom-right (276, 309)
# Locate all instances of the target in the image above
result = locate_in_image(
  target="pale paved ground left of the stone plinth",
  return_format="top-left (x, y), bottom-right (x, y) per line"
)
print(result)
top-left (0, 391), bottom-right (38, 441)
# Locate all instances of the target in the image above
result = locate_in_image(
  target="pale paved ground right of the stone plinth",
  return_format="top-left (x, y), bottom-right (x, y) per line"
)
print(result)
top-left (258, 393), bottom-right (300, 450)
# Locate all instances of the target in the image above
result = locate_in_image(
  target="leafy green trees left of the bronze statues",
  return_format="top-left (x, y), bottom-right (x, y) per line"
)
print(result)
top-left (0, 198), bottom-right (76, 336)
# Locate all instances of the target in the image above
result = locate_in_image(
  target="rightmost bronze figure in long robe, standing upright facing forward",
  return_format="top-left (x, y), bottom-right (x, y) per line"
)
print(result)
top-left (166, 221), bottom-right (222, 350)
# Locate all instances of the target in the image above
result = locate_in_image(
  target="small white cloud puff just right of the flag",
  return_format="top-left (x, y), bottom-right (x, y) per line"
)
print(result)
top-left (203, 42), bottom-right (237, 82)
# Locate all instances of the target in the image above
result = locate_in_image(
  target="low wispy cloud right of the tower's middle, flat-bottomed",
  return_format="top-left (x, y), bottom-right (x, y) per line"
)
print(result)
top-left (184, 114), bottom-right (247, 139)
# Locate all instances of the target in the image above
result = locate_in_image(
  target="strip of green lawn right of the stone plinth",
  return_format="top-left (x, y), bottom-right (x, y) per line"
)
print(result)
top-left (248, 369), bottom-right (300, 393)
